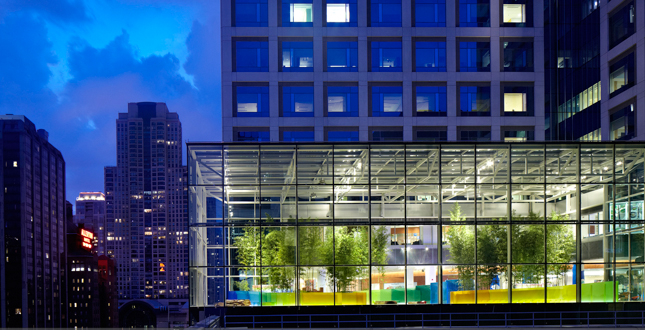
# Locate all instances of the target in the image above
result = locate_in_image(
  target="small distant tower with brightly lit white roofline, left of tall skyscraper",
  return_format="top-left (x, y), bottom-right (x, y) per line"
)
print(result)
top-left (74, 192), bottom-right (107, 255)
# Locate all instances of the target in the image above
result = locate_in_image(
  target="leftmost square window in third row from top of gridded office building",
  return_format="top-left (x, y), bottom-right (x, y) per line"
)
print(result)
top-left (233, 86), bottom-right (269, 117)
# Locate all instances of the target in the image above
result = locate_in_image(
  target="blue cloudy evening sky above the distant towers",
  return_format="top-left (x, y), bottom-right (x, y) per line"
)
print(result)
top-left (0, 0), bottom-right (221, 203)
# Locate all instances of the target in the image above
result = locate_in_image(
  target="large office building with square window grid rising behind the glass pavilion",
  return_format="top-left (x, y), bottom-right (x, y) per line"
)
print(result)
top-left (221, 0), bottom-right (645, 142)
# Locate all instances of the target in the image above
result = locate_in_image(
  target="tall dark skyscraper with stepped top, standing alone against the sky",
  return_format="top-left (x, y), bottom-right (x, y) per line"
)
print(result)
top-left (105, 102), bottom-right (188, 300)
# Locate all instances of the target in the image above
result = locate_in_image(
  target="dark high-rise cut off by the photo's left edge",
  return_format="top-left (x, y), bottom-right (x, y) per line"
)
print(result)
top-left (0, 115), bottom-right (67, 328)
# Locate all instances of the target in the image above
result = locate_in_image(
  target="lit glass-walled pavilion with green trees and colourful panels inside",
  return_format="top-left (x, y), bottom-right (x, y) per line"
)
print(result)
top-left (187, 143), bottom-right (645, 307)
